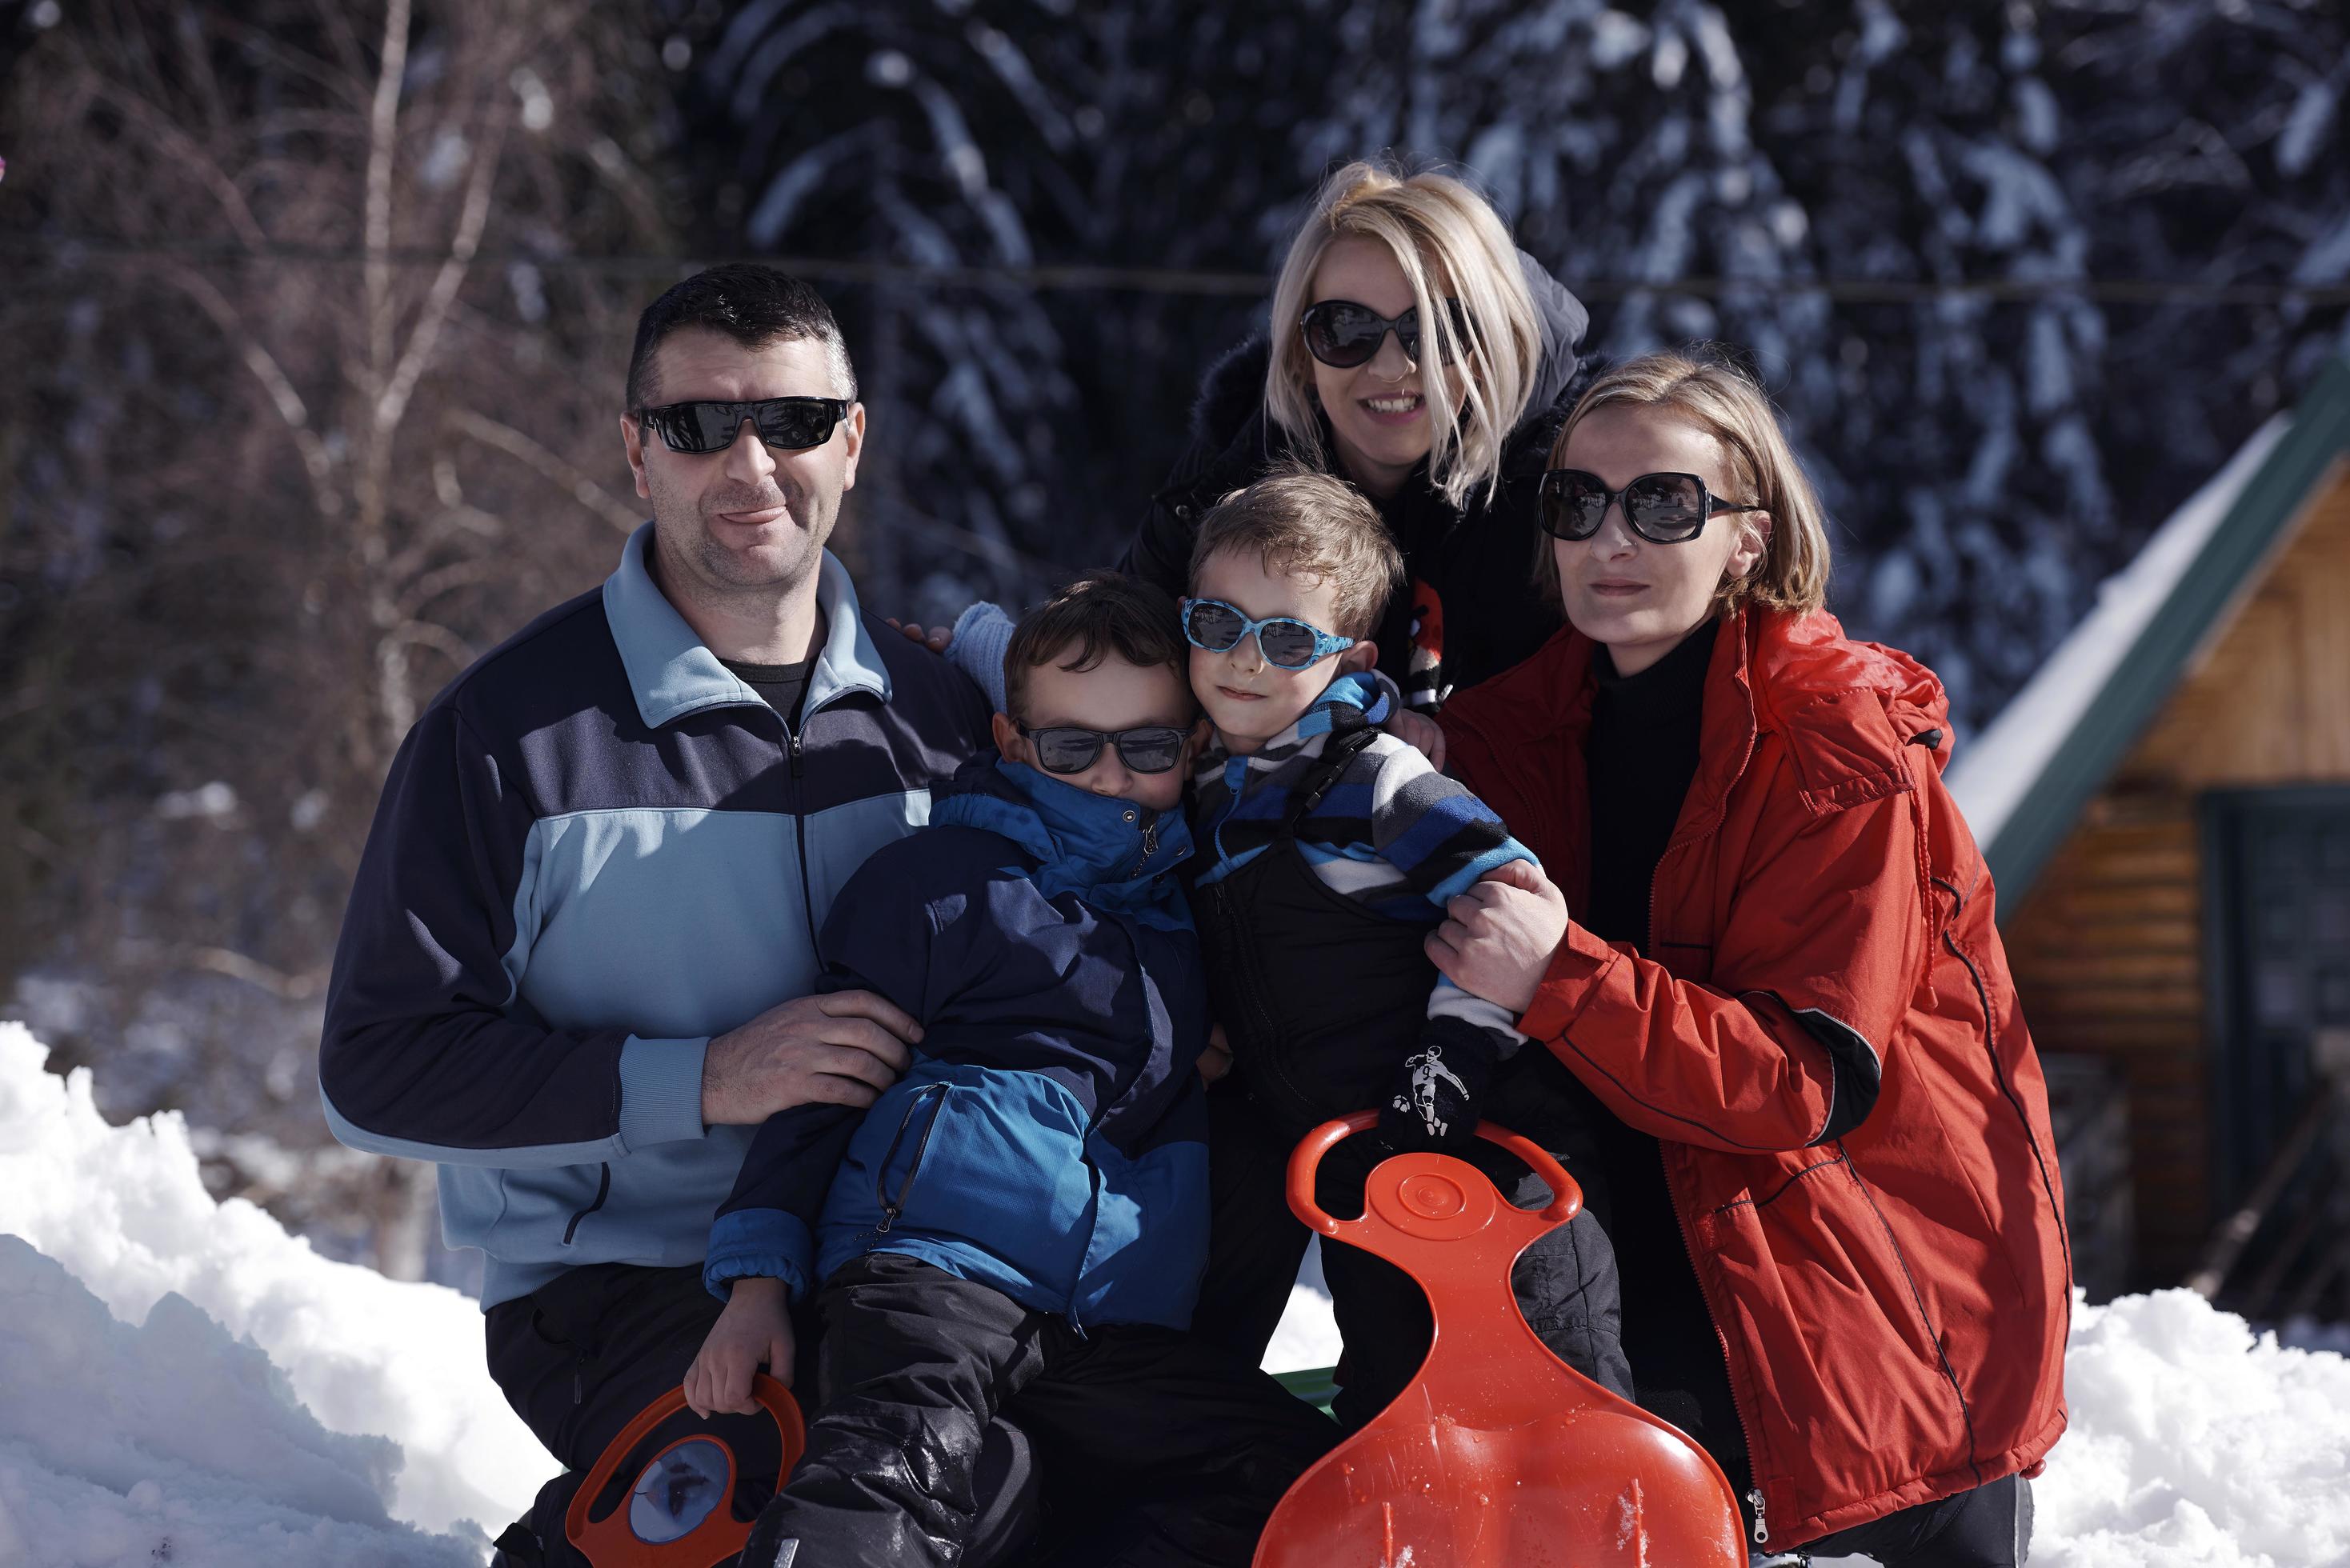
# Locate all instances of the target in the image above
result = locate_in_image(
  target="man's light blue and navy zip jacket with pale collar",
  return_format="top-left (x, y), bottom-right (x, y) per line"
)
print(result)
top-left (319, 524), bottom-right (989, 1307)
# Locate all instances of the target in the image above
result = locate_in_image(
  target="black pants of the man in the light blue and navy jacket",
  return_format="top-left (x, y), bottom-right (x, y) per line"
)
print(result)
top-left (484, 1262), bottom-right (1039, 1568)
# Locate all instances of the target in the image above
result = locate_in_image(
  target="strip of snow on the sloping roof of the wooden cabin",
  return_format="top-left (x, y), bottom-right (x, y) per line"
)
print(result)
top-left (1948, 414), bottom-right (2292, 844)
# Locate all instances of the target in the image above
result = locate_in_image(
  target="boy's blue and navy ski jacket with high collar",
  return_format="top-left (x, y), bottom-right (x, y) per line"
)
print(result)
top-left (703, 757), bottom-right (1208, 1328)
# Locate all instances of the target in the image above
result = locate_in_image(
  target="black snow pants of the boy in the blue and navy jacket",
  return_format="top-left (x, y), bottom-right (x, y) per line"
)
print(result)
top-left (743, 1253), bottom-right (1339, 1568)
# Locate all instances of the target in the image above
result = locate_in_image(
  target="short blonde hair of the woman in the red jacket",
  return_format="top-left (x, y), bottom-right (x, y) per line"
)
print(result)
top-left (1535, 348), bottom-right (1828, 614)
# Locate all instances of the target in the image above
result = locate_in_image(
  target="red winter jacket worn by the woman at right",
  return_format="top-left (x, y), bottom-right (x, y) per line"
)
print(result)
top-left (1443, 611), bottom-right (2072, 1549)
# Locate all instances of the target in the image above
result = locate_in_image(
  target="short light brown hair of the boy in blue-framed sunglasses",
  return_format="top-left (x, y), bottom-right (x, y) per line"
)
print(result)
top-left (1191, 463), bottom-right (1403, 637)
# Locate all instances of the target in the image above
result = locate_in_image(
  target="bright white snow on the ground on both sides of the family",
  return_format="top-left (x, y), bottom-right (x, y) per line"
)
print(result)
top-left (0, 1022), bottom-right (2350, 1568)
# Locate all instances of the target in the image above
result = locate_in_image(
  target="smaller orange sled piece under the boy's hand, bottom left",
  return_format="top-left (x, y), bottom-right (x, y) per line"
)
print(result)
top-left (564, 1373), bottom-right (808, 1568)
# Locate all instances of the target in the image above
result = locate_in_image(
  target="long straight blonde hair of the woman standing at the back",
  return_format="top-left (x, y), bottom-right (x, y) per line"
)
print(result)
top-left (1264, 162), bottom-right (1542, 506)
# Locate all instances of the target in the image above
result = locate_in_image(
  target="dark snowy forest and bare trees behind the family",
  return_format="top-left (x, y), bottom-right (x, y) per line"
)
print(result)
top-left (0, 0), bottom-right (2350, 1277)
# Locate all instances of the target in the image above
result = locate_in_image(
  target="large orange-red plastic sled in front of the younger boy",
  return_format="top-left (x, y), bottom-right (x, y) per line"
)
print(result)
top-left (1255, 1112), bottom-right (1746, 1568)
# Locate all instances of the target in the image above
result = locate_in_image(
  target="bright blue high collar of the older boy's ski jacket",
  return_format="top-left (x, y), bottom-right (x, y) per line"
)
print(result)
top-left (931, 754), bottom-right (1191, 931)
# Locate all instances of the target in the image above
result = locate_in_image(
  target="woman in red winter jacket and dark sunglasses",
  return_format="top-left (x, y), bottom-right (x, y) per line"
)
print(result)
top-left (1429, 355), bottom-right (2070, 1568)
